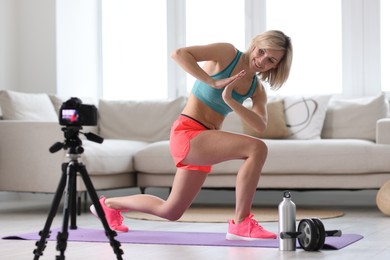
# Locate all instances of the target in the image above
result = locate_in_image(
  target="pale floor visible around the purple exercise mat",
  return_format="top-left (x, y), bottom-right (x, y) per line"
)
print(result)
top-left (0, 191), bottom-right (390, 260)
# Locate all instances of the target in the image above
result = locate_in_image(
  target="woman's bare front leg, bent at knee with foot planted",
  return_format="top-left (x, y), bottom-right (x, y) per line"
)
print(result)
top-left (183, 131), bottom-right (268, 223)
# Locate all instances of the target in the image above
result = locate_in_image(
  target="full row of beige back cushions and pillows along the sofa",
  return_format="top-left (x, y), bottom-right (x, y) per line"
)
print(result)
top-left (0, 90), bottom-right (390, 142)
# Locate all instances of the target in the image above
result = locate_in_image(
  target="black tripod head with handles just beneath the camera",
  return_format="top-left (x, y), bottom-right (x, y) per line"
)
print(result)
top-left (49, 126), bottom-right (104, 155)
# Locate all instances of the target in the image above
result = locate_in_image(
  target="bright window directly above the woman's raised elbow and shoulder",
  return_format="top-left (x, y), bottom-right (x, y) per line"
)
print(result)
top-left (186, 0), bottom-right (246, 92)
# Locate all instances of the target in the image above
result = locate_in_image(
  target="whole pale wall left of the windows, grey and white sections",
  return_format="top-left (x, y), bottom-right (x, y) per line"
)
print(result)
top-left (0, 0), bottom-right (100, 97)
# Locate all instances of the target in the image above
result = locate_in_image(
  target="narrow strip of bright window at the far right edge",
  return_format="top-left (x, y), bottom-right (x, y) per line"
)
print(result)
top-left (381, 0), bottom-right (390, 91)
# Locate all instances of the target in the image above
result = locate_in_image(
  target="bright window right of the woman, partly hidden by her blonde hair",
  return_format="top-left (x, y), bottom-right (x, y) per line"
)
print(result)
top-left (266, 0), bottom-right (342, 95)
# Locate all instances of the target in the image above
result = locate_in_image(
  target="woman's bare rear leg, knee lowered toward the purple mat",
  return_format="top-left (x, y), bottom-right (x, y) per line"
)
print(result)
top-left (106, 169), bottom-right (207, 221)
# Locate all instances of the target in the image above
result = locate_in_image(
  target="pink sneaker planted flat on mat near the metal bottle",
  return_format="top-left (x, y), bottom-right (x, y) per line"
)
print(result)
top-left (226, 214), bottom-right (276, 241)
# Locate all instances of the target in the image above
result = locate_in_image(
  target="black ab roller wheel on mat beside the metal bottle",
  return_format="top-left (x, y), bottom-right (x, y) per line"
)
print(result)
top-left (297, 218), bottom-right (341, 251)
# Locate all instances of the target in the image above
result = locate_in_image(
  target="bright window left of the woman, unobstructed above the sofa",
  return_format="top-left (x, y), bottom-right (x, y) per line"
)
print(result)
top-left (102, 0), bottom-right (168, 100)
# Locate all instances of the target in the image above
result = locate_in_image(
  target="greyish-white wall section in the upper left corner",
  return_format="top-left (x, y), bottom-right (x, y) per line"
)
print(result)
top-left (0, 0), bottom-right (56, 92)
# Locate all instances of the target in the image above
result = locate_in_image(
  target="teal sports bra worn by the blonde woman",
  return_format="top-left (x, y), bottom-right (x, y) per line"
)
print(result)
top-left (192, 50), bottom-right (257, 116)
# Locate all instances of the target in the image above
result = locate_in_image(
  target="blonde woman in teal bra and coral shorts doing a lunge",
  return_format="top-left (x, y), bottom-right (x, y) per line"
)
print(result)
top-left (91, 31), bottom-right (292, 240)
